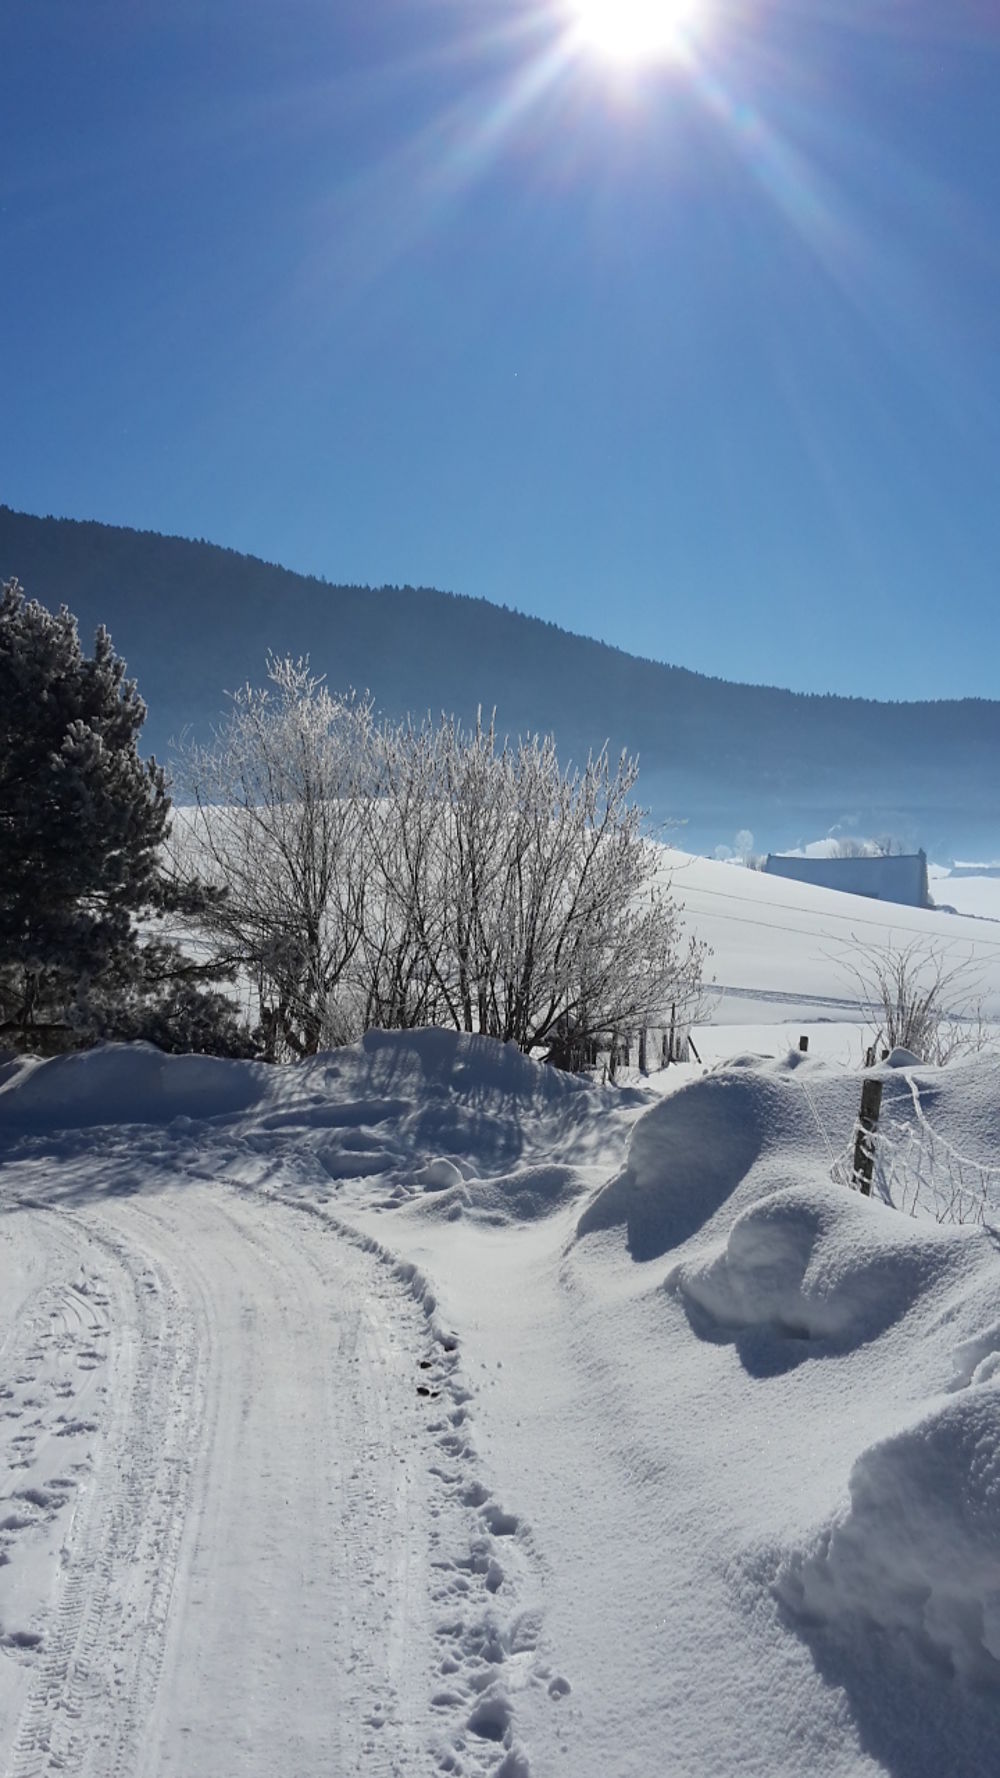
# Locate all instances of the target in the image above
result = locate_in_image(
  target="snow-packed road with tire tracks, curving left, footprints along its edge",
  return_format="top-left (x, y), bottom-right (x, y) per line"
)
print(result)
top-left (0, 1165), bottom-right (550, 1778)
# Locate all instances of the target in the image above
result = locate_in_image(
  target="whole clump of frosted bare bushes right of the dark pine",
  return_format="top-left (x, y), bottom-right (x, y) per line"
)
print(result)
top-left (181, 660), bottom-right (705, 1056)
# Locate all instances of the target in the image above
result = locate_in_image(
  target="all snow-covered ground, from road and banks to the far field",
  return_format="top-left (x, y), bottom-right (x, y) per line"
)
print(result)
top-left (0, 859), bottom-right (1000, 1778)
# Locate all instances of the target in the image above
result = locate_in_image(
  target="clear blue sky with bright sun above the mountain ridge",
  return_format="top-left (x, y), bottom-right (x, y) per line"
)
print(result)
top-left (0, 0), bottom-right (1000, 697)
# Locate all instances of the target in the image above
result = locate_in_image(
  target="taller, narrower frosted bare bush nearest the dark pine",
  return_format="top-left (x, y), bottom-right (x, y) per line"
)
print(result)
top-left (178, 658), bottom-right (374, 1060)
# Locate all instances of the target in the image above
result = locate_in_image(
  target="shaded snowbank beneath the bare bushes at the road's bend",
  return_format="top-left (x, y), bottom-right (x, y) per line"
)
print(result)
top-left (0, 1029), bottom-right (629, 1223)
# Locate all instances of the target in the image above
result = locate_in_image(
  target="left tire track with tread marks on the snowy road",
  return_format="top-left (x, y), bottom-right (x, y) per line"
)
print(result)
top-left (0, 1213), bottom-right (204, 1778)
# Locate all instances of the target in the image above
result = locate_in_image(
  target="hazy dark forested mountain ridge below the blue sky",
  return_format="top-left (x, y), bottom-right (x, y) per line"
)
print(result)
top-left (0, 507), bottom-right (1000, 853)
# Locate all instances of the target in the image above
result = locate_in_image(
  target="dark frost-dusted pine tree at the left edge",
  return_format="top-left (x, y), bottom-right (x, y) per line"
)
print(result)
top-left (0, 581), bottom-right (247, 1051)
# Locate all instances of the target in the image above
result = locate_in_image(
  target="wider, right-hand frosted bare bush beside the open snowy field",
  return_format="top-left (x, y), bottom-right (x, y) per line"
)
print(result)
top-left (396, 722), bottom-right (705, 1051)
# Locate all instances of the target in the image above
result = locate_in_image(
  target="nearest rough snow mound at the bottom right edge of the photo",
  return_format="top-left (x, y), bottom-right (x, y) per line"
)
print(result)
top-left (778, 1387), bottom-right (1000, 1689)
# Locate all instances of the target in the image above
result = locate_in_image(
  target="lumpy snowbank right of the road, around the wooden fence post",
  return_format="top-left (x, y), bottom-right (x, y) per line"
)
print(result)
top-left (577, 1054), bottom-right (1000, 1749)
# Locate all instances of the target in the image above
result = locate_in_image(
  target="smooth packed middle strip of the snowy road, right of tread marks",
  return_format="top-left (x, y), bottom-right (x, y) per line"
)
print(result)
top-left (123, 1188), bottom-right (422, 1774)
